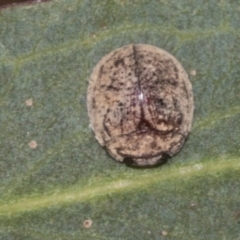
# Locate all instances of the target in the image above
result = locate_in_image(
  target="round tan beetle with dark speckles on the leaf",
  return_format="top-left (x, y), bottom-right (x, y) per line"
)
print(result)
top-left (87, 44), bottom-right (193, 166)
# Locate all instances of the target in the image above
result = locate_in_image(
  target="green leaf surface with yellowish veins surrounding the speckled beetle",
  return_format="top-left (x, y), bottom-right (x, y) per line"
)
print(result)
top-left (0, 0), bottom-right (240, 240)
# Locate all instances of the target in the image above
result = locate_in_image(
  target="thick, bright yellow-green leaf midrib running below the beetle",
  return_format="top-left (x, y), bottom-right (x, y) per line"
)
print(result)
top-left (0, 158), bottom-right (240, 215)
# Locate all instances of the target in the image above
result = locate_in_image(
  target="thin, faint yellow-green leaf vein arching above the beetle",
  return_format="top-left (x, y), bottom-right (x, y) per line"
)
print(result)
top-left (0, 23), bottom-right (240, 67)
